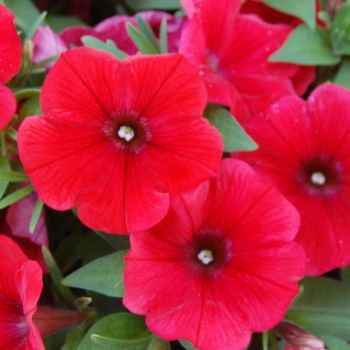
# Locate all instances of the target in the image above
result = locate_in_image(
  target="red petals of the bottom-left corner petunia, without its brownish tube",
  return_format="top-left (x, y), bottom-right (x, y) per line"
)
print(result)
top-left (0, 235), bottom-right (45, 350)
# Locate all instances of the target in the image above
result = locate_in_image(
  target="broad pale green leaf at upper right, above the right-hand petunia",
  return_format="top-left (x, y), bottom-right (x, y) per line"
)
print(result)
top-left (269, 24), bottom-right (340, 66)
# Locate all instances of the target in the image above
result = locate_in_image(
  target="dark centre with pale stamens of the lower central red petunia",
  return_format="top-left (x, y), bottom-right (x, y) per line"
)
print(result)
top-left (188, 229), bottom-right (232, 272)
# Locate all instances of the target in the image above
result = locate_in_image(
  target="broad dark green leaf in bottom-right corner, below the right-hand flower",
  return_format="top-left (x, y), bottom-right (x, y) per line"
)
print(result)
top-left (285, 277), bottom-right (350, 341)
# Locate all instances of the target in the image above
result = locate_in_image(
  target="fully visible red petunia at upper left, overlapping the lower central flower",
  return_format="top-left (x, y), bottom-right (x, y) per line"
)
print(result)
top-left (18, 48), bottom-right (223, 233)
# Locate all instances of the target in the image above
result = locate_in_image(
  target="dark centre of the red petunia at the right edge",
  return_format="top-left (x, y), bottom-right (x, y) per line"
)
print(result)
top-left (298, 155), bottom-right (343, 195)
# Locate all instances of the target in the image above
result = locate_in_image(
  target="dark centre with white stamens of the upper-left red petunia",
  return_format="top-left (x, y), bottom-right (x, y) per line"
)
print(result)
top-left (106, 116), bottom-right (150, 153)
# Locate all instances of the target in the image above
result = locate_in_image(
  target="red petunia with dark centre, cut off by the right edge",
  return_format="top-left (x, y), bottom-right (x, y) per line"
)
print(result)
top-left (232, 84), bottom-right (350, 276)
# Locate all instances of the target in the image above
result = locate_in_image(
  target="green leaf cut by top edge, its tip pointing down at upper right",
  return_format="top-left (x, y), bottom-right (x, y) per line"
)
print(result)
top-left (263, 0), bottom-right (316, 29)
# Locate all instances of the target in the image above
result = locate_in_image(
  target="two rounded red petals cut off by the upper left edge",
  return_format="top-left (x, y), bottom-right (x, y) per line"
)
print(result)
top-left (0, 4), bottom-right (22, 130)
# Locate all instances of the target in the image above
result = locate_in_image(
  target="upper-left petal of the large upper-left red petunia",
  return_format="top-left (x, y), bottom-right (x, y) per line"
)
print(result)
top-left (41, 47), bottom-right (125, 127)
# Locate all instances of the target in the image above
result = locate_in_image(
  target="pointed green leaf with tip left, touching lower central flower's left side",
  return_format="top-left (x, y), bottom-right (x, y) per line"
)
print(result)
top-left (61, 250), bottom-right (128, 297)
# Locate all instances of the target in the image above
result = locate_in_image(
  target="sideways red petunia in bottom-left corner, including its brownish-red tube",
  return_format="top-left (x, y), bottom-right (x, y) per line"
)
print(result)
top-left (0, 234), bottom-right (87, 350)
